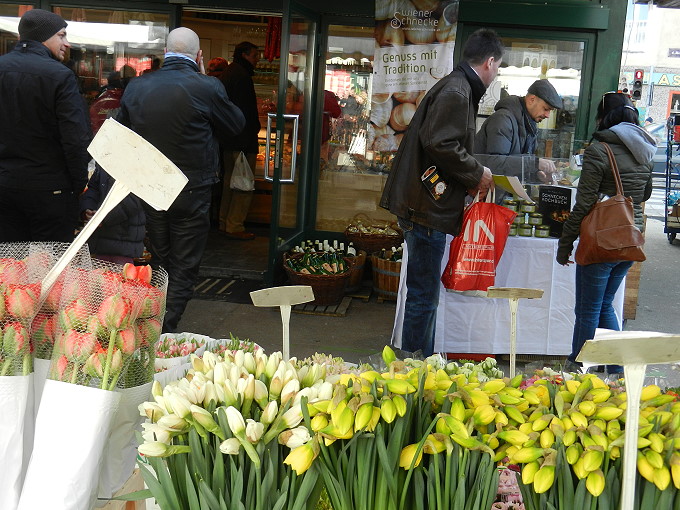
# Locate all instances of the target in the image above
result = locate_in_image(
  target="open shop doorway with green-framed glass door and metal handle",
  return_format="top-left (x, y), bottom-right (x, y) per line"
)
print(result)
top-left (181, 5), bottom-right (372, 285)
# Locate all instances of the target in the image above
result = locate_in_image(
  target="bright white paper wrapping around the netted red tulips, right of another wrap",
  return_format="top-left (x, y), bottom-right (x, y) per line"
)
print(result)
top-left (17, 380), bottom-right (121, 510)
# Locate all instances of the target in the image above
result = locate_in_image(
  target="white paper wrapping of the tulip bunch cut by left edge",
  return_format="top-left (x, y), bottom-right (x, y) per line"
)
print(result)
top-left (0, 375), bottom-right (33, 510)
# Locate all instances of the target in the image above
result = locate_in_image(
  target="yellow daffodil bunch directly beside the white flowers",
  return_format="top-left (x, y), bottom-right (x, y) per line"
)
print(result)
top-left (286, 347), bottom-right (498, 510)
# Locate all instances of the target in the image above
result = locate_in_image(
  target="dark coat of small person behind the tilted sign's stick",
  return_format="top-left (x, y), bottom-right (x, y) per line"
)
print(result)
top-left (80, 166), bottom-right (146, 258)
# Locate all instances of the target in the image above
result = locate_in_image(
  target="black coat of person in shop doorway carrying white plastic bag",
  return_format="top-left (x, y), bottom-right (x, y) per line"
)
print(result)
top-left (220, 58), bottom-right (261, 154)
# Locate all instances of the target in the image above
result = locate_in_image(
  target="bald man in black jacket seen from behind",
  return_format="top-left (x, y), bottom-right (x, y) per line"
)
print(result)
top-left (116, 27), bottom-right (245, 333)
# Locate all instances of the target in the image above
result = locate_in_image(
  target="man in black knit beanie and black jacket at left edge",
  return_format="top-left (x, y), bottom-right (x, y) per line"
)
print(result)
top-left (0, 9), bottom-right (91, 242)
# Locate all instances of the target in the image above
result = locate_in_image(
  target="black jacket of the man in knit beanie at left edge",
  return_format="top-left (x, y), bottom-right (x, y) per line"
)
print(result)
top-left (0, 41), bottom-right (92, 193)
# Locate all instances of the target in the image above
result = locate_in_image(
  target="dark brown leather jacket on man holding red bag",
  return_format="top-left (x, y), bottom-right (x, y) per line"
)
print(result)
top-left (380, 64), bottom-right (485, 235)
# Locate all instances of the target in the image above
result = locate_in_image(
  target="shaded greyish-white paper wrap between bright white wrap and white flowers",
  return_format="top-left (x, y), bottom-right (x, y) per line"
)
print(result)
top-left (97, 383), bottom-right (153, 507)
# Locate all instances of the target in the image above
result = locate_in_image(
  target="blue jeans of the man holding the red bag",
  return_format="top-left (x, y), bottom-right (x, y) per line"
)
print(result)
top-left (399, 218), bottom-right (446, 356)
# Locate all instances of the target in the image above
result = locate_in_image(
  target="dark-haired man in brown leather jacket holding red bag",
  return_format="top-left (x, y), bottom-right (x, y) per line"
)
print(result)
top-left (380, 29), bottom-right (503, 356)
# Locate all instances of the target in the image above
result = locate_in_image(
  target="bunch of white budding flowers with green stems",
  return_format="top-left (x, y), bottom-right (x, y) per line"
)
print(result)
top-left (135, 349), bottom-right (332, 510)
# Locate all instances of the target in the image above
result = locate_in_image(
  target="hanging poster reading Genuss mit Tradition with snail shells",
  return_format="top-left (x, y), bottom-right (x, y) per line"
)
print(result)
top-left (367, 0), bottom-right (458, 152)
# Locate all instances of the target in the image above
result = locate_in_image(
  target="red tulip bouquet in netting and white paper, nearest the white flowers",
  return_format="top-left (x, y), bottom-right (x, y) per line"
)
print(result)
top-left (19, 260), bottom-right (167, 510)
